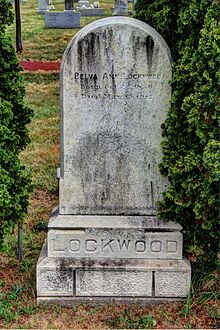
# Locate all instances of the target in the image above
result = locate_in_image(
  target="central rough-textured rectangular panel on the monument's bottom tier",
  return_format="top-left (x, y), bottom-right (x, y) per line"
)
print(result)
top-left (76, 270), bottom-right (152, 297)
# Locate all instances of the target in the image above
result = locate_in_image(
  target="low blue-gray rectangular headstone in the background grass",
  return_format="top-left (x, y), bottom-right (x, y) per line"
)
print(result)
top-left (45, 10), bottom-right (80, 29)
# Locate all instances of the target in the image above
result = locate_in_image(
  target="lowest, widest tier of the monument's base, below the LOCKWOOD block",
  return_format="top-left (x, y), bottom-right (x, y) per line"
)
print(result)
top-left (37, 240), bottom-right (191, 304)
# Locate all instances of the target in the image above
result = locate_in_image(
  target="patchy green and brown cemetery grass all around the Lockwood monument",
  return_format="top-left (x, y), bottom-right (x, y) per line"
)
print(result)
top-left (0, 0), bottom-right (219, 329)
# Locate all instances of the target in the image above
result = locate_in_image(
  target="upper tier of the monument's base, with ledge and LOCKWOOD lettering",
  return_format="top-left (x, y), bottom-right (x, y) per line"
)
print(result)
top-left (48, 208), bottom-right (182, 260)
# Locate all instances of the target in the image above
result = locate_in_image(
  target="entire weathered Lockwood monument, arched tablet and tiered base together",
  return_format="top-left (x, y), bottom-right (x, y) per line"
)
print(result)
top-left (37, 17), bottom-right (191, 304)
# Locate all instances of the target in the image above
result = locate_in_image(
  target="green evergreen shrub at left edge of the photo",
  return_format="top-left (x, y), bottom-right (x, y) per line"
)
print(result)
top-left (0, 0), bottom-right (32, 246)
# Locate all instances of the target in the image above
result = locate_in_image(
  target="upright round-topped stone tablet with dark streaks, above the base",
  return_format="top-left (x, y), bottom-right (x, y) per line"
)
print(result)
top-left (59, 17), bottom-right (171, 215)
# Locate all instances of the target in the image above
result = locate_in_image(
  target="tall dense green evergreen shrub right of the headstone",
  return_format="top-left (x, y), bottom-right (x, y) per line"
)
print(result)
top-left (136, 0), bottom-right (220, 268)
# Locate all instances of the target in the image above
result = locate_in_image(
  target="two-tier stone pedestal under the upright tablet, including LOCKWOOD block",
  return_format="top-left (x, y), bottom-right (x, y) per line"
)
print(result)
top-left (37, 208), bottom-right (191, 305)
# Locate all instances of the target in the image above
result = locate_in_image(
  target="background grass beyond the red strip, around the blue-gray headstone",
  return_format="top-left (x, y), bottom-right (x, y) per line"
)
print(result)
top-left (8, 0), bottom-right (132, 60)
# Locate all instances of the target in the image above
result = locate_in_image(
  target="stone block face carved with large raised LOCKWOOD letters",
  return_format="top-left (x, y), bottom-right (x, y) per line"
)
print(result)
top-left (48, 228), bottom-right (182, 259)
